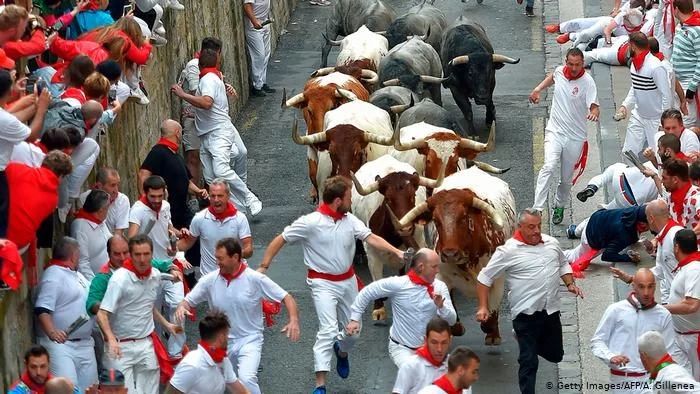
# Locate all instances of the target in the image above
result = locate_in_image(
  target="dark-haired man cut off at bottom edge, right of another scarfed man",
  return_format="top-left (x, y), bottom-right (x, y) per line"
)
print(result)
top-left (418, 346), bottom-right (481, 394)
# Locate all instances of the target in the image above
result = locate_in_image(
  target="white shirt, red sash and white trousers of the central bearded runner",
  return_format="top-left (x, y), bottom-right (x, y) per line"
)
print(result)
top-left (282, 204), bottom-right (372, 372)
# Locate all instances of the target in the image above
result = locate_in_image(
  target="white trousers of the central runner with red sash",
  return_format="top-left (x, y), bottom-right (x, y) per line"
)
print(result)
top-left (306, 276), bottom-right (359, 372)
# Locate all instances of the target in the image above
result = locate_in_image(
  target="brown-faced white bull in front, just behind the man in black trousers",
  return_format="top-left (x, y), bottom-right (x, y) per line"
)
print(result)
top-left (394, 167), bottom-right (515, 345)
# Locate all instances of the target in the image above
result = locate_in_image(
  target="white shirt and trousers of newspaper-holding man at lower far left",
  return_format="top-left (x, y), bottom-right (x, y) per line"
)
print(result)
top-left (34, 264), bottom-right (97, 393)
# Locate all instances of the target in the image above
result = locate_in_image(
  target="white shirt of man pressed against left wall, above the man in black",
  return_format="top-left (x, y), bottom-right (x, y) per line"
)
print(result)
top-left (194, 73), bottom-right (232, 137)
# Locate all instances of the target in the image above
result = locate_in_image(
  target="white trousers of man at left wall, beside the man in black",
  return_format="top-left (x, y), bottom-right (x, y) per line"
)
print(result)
top-left (199, 129), bottom-right (257, 208)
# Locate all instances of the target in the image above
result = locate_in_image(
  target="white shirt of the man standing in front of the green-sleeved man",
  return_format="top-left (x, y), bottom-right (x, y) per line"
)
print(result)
top-left (100, 268), bottom-right (161, 339)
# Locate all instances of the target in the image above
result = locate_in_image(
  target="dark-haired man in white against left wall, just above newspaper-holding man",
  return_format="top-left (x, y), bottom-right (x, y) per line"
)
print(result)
top-left (71, 189), bottom-right (112, 280)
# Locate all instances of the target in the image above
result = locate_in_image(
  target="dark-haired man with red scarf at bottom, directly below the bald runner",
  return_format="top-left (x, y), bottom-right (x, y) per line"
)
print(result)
top-left (392, 316), bottom-right (452, 394)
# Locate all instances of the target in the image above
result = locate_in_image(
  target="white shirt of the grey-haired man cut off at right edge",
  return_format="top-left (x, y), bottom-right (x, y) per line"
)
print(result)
top-left (668, 261), bottom-right (700, 333)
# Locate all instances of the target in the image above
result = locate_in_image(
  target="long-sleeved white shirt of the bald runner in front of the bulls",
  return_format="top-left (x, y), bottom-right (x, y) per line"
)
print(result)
top-left (350, 275), bottom-right (457, 348)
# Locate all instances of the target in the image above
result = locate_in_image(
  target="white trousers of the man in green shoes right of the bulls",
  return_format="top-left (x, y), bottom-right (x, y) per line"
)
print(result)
top-left (533, 131), bottom-right (584, 209)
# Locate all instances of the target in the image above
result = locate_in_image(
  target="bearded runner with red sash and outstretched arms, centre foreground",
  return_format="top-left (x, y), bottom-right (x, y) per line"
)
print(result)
top-left (258, 176), bottom-right (403, 394)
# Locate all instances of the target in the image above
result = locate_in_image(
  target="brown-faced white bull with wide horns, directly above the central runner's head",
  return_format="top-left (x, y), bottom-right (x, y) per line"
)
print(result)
top-left (292, 100), bottom-right (393, 195)
